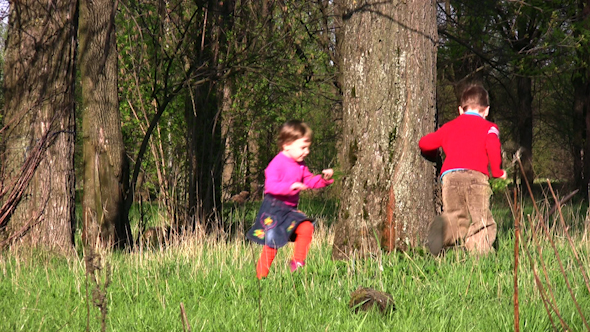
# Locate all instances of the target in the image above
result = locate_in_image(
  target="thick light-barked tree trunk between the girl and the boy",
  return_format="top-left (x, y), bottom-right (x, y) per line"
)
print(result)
top-left (332, 0), bottom-right (437, 259)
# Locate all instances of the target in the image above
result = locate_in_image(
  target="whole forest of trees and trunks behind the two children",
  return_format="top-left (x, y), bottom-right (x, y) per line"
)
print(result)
top-left (0, 0), bottom-right (590, 330)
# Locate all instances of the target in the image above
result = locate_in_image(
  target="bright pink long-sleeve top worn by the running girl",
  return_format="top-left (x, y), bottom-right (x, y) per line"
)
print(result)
top-left (264, 152), bottom-right (334, 206)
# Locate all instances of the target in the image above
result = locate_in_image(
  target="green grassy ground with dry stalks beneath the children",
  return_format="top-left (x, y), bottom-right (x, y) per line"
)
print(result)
top-left (0, 193), bottom-right (590, 331)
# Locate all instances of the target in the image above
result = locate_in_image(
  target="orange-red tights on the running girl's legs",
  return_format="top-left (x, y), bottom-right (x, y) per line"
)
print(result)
top-left (256, 221), bottom-right (313, 279)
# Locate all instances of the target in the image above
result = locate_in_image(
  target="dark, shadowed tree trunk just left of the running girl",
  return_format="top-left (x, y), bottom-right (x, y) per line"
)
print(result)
top-left (185, 0), bottom-right (235, 227)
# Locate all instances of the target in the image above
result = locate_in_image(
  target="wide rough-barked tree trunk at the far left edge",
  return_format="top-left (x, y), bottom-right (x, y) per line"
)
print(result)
top-left (3, 0), bottom-right (78, 253)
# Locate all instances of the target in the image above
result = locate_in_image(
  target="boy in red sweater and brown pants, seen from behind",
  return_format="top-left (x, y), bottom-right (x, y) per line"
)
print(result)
top-left (419, 85), bottom-right (506, 256)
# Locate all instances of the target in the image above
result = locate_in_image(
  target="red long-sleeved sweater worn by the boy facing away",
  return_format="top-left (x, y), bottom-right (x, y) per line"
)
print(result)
top-left (419, 113), bottom-right (504, 178)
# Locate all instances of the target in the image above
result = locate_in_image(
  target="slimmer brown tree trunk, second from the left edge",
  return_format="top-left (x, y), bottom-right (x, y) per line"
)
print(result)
top-left (80, 0), bottom-right (132, 247)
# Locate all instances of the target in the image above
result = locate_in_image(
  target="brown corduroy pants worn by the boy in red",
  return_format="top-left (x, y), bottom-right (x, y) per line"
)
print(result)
top-left (442, 170), bottom-right (497, 254)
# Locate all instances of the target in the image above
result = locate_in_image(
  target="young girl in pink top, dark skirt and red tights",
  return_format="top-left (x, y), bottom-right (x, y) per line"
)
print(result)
top-left (247, 120), bottom-right (334, 279)
